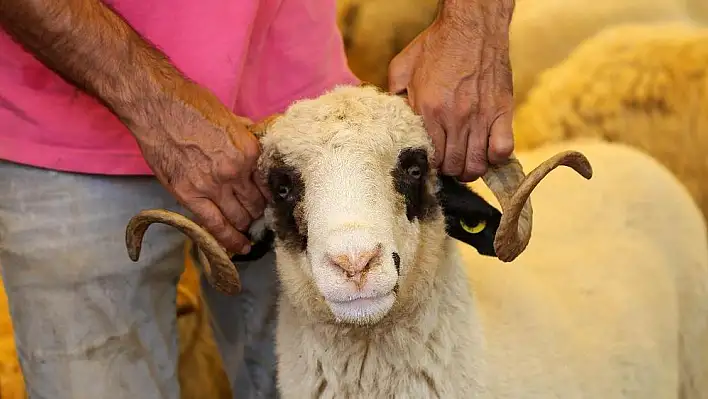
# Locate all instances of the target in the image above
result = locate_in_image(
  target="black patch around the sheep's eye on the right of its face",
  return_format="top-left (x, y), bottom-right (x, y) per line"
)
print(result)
top-left (391, 148), bottom-right (439, 222)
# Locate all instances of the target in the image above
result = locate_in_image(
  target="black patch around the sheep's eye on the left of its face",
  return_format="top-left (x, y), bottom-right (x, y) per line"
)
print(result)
top-left (267, 157), bottom-right (307, 251)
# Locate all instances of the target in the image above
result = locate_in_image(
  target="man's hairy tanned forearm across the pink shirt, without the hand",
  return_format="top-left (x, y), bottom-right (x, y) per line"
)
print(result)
top-left (0, 0), bottom-right (185, 123)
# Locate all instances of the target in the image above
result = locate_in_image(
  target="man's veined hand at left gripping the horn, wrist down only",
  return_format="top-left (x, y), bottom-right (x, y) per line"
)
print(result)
top-left (126, 83), bottom-right (268, 253)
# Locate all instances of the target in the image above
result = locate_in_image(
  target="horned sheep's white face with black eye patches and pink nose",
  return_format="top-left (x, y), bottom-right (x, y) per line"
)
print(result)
top-left (259, 87), bottom-right (444, 324)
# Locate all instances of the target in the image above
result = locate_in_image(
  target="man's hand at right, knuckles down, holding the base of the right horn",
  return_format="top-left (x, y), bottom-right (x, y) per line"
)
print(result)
top-left (389, 0), bottom-right (514, 182)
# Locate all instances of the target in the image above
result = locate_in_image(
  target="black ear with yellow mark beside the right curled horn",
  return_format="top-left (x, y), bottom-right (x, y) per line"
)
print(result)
top-left (438, 174), bottom-right (501, 256)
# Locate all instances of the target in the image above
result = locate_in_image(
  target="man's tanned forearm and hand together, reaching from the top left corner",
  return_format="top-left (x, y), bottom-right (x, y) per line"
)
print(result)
top-left (0, 0), bottom-right (267, 253)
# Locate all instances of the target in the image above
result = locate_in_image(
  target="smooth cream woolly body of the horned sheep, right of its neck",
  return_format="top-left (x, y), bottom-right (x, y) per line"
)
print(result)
top-left (458, 139), bottom-right (708, 399)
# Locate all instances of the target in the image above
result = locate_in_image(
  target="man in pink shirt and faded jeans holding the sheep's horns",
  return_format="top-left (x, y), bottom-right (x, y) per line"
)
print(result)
top-left (0, 0), bottom-right (514, 399)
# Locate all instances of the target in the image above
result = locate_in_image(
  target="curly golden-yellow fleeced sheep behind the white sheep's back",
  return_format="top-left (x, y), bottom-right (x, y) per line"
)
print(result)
top-left (514, 23), bottom-right (708, 222)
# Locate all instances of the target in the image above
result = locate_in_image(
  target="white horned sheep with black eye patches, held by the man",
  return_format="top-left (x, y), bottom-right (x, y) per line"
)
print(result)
top-left (121, 86), bottom-right (708, 399)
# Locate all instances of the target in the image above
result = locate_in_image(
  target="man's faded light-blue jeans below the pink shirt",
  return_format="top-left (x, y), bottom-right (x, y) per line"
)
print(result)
top-left (0, 161), bottom-right (278, 399)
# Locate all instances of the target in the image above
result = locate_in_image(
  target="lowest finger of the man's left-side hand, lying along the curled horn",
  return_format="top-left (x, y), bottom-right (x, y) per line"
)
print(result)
top-left (187, 198), bottom-right (251, 254)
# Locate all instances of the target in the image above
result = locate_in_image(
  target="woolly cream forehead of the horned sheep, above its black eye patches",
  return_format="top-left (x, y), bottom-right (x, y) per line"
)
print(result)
top-left (262, 86), bottom-right (432, 168)
